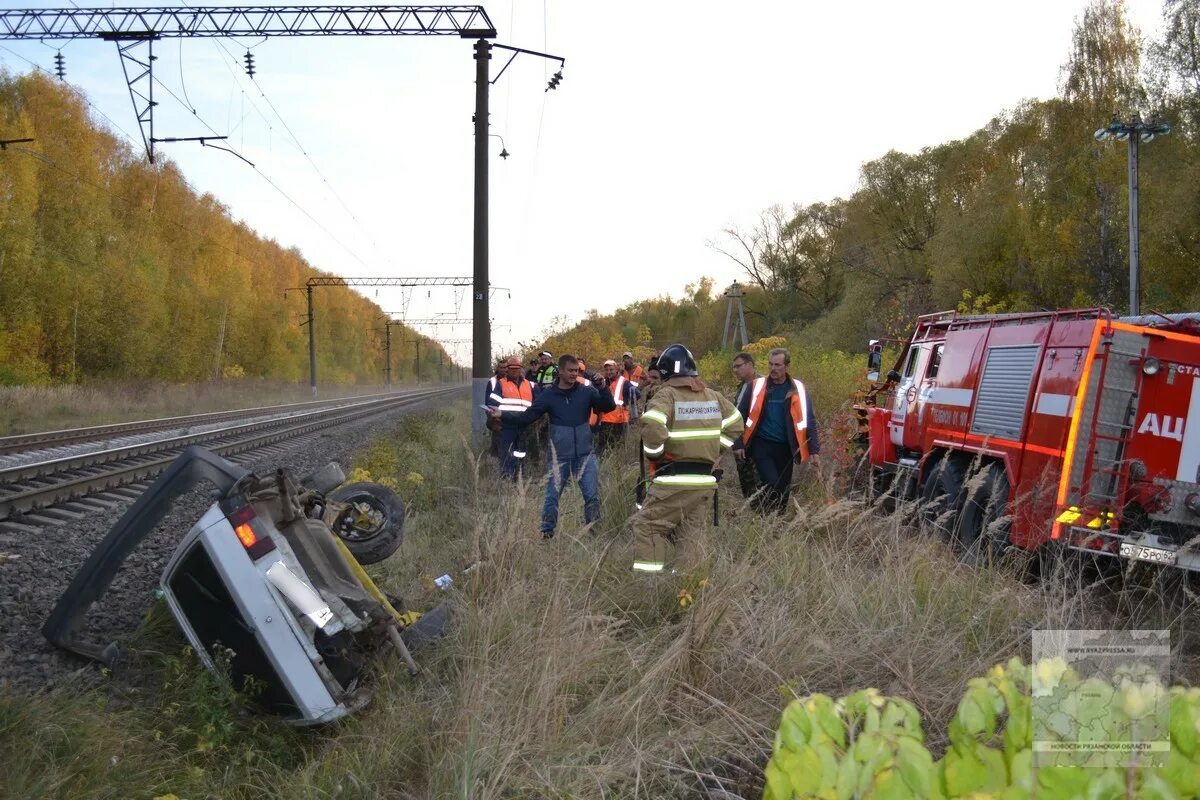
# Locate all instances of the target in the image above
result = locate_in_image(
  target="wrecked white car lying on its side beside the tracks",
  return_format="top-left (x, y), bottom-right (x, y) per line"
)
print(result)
top-left (42, 447), bottom-right (445, 724)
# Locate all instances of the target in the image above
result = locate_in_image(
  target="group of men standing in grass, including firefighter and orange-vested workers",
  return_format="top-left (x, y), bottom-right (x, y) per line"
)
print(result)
top-left (488, 344), bottom-right (820, 573)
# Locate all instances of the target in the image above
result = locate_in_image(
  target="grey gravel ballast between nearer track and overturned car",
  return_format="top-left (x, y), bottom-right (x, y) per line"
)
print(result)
top-left (0, 397), bottom-right (446, 693)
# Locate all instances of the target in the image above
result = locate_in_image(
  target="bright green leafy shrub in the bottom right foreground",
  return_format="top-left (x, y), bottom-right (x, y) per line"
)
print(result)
top-left (763, 658), bottom-right (1200, 800)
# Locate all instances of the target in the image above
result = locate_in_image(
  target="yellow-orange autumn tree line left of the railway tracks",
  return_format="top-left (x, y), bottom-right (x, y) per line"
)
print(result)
top-left (0, 73), bottom-right (457, 385)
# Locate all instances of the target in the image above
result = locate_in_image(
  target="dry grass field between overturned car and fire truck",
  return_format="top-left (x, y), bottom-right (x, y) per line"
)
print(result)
top-left (0, 403), bottom-right (1200, 800)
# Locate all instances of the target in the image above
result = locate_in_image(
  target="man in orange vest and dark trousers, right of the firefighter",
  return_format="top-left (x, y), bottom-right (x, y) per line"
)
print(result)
top-left (734, 348), bottom-right (821, 512)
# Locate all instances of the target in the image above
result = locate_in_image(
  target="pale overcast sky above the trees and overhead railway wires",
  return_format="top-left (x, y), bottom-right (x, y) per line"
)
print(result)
top-left (0, 0), bottom-right (1160, 361)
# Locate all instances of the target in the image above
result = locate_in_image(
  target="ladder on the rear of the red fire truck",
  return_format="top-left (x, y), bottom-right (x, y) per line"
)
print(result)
top-left (1072, 331), bottom-right (1148, 530)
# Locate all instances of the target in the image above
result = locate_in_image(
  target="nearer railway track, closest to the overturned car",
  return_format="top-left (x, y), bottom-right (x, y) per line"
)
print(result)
top-left (0, 386), bottom-right (462, 531)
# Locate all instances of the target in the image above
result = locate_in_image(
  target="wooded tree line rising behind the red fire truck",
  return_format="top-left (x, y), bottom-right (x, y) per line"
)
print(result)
top-left (546, 0), bottom-right (1200, 357)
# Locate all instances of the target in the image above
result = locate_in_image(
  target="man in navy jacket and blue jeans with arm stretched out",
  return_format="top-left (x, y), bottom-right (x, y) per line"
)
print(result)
top-left (488, 355), bottom-right (617, 539)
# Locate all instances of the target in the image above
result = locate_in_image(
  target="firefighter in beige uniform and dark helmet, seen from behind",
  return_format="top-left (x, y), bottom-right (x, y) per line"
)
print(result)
top-left (634, 344), bottom-right (742, 572)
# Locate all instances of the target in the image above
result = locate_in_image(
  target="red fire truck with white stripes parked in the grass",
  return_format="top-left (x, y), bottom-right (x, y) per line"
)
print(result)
top-left (857, 308), bottom-right (1200, 571)
